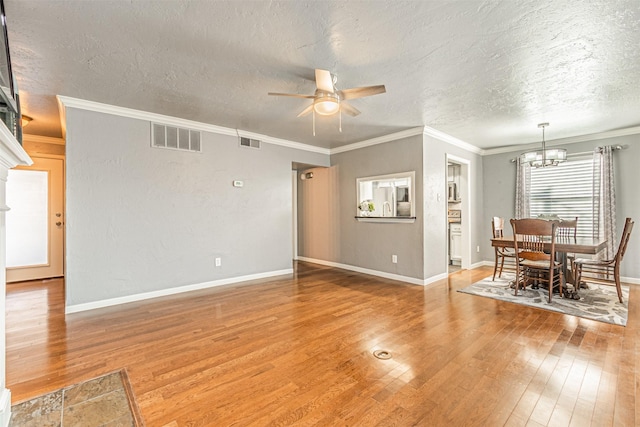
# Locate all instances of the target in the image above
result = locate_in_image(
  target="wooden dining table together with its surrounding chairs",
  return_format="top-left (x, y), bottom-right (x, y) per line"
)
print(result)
top-left (491, 215), bottom-right (634, 304)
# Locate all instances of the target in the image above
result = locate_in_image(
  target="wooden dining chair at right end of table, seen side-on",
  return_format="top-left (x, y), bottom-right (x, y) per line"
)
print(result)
top-left (573, 218), bottom-right (634, 303)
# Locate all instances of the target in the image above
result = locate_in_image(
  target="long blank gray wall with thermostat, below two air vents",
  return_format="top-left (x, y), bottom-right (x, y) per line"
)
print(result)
top-left (66, 108), bottom-right (329, 306)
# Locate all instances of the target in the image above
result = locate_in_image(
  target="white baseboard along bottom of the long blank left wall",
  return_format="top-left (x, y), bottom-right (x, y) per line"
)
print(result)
top-left (65, 268), bottom-right (293, 314)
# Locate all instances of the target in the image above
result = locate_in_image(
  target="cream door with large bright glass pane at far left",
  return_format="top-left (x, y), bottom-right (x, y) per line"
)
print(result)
top-left (6, 157), bottom-right (64, 283)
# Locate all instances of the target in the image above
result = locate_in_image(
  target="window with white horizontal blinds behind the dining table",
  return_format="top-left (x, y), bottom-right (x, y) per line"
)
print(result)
top-left (529, 157), bottom-right (594, 237)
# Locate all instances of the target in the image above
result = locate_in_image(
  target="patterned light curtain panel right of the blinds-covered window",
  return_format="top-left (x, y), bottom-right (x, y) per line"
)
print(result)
top-left (593, 146), bottom-right (616, 259)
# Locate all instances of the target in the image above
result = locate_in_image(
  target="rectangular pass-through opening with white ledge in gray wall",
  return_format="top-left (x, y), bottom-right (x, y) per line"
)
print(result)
top-left (356, 172), bottom-right (415, 218)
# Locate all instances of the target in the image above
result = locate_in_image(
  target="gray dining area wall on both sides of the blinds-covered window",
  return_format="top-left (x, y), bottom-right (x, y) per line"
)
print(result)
top-left (482, 135), bottom-right (640, 279)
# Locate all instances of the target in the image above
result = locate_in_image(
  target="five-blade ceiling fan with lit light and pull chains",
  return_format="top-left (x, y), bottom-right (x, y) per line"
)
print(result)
top-left (269, 68), bottom-right (387, 136)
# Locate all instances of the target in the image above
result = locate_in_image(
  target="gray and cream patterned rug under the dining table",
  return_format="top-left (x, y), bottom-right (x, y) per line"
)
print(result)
top-left (458, 274), bottom-right (629, 326)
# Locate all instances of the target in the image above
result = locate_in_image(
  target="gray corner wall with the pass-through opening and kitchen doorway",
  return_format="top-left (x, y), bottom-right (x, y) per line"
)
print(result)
top-left (298, 135), bottom-right (484, 280)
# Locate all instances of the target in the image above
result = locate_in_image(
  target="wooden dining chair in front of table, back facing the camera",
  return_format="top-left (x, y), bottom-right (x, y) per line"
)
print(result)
top-left (511, 218), bottom-right (564, 302)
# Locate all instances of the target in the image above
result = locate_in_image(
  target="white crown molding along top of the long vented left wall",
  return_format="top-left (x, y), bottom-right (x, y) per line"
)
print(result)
top-left (57, 95), bottom-right (329, 155)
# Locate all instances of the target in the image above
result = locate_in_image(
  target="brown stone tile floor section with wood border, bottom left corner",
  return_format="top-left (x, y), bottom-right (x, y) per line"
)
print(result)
top-left (9, 369), bottom-right (144, 427)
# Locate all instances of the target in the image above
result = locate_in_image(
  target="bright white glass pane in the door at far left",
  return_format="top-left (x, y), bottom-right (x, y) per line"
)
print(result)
top-left (6, 170), bottom-right (49, 267)
